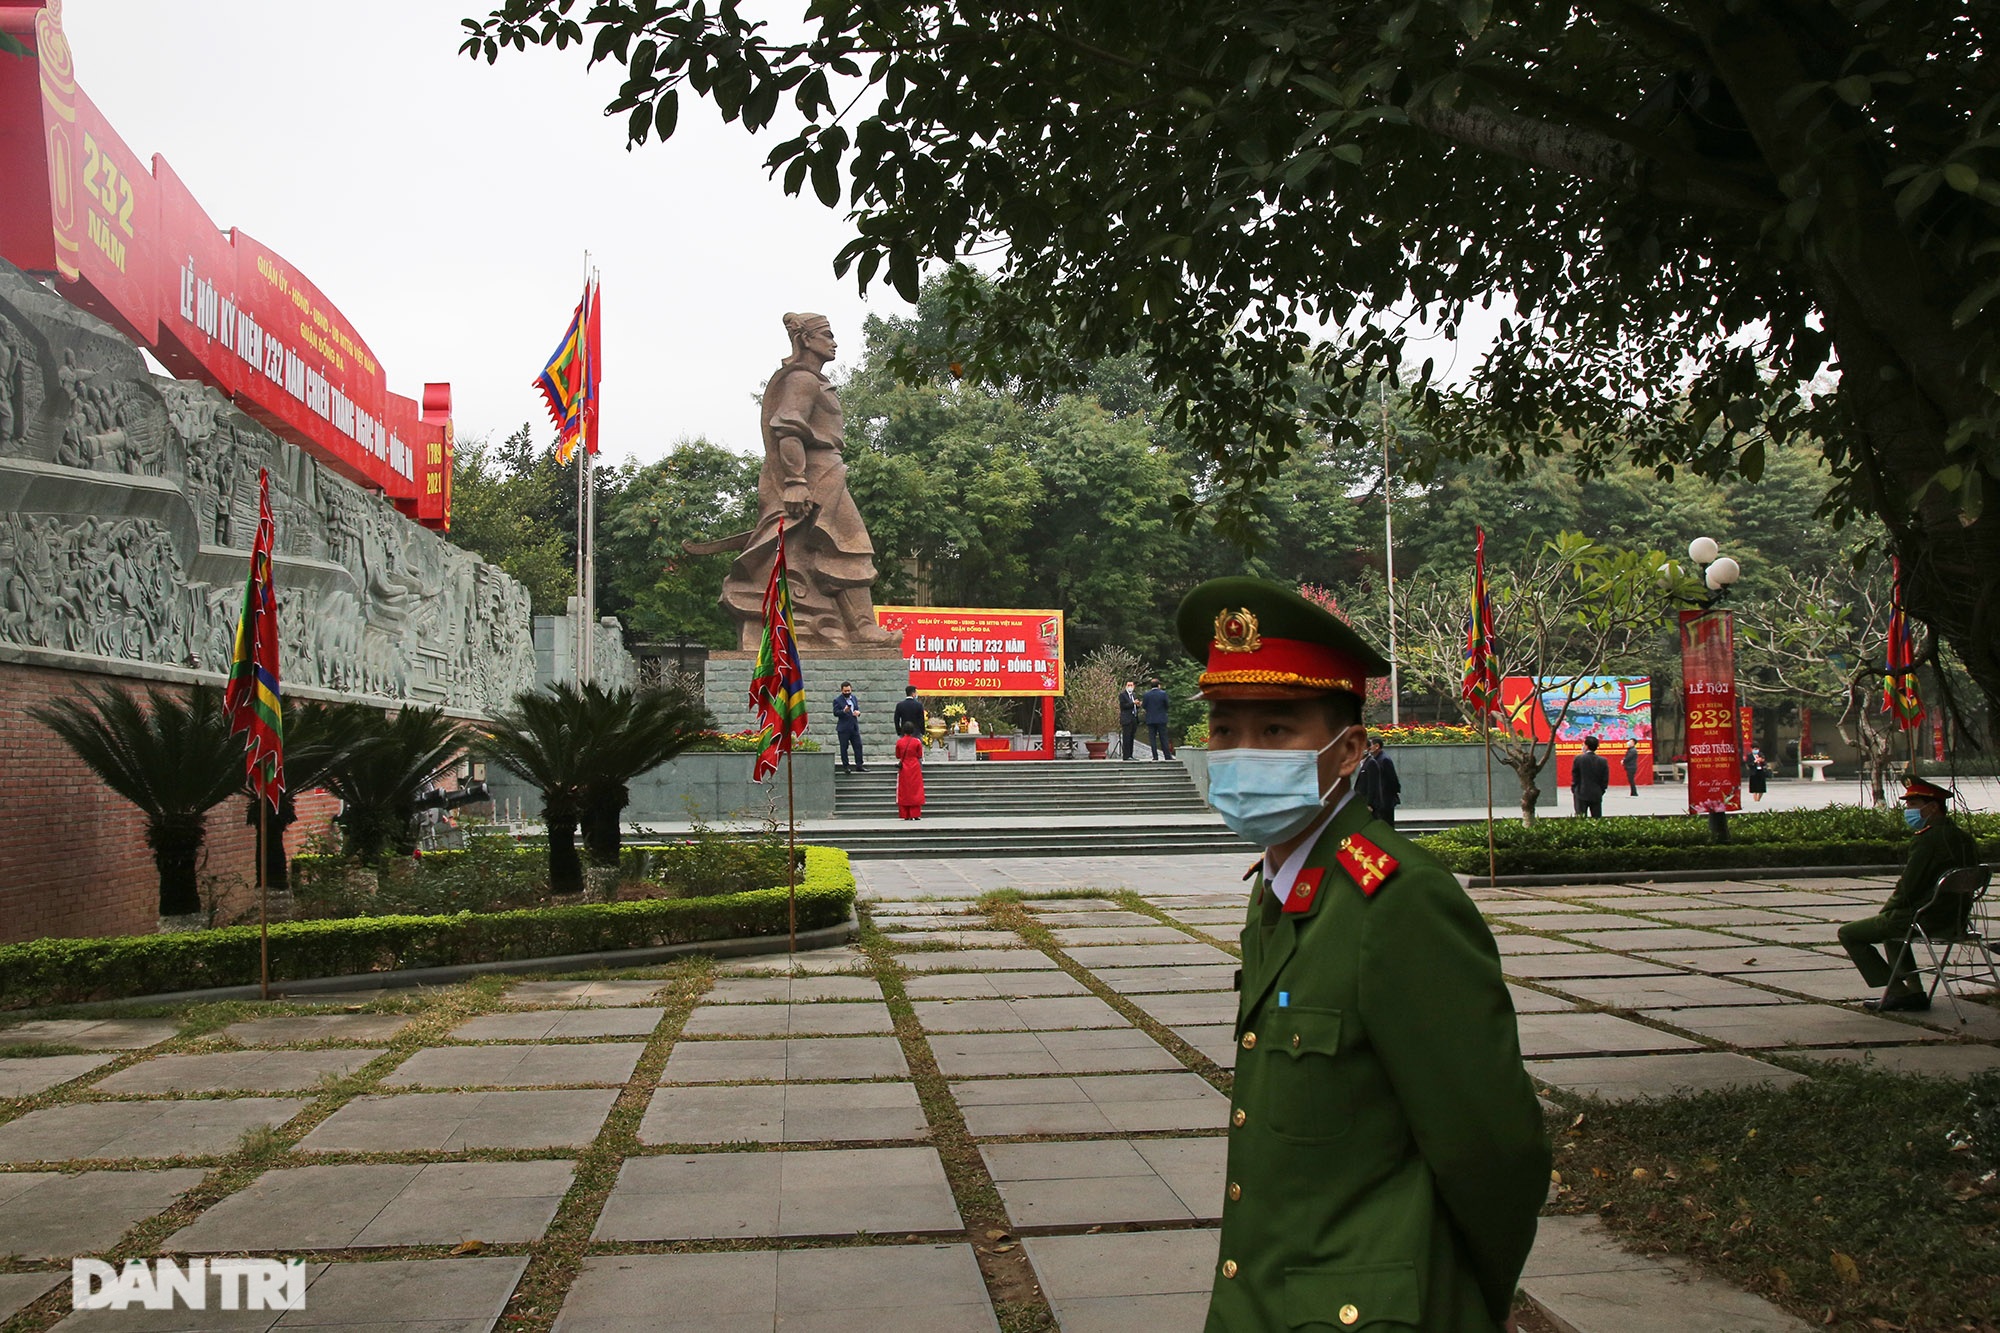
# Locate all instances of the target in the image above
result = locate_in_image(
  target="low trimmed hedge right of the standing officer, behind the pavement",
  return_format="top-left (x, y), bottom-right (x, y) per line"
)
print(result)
top-left (1416, 807), bottom-right (2000, 875)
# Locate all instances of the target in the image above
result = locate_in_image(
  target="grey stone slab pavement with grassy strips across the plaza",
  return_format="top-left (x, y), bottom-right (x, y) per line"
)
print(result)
top-left (0, 859), bottom-right (2000, 1333)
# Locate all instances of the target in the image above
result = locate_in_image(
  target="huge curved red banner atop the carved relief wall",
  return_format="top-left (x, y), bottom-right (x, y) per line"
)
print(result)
top-left (0, 0), bottom-right (452, 528)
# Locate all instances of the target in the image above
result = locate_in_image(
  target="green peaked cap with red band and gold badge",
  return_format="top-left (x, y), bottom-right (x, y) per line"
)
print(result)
top-left (1176, 578), bottom-right (1388, 699)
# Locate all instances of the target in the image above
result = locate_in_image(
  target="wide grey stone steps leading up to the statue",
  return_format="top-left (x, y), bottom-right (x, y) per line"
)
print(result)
top-left (814, 759), bottom-right (1256, 859)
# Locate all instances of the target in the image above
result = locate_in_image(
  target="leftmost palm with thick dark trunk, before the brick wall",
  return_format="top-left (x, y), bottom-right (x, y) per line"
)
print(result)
top-left (34, 685), bottom-right (244, 917)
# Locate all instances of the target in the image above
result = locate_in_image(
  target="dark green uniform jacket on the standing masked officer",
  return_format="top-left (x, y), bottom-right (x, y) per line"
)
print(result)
top-left (1206, 801), bottom-right (1550, 1333)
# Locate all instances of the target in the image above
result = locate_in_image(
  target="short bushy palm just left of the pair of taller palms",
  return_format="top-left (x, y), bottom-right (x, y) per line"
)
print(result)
top-left (324, 707), bottom-right (466, 863)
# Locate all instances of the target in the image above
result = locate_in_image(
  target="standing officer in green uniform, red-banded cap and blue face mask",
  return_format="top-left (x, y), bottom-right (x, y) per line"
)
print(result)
top-left (1178, 578), bottom-right (1550, 1333)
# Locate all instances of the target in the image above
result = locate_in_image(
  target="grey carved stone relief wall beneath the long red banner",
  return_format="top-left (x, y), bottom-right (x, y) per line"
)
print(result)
top-left (0, 262), bottom-right (536, 715)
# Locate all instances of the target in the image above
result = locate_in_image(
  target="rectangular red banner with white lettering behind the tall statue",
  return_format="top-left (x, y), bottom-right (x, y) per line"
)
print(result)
top-left (876, 606), bottom-right (1062, 695)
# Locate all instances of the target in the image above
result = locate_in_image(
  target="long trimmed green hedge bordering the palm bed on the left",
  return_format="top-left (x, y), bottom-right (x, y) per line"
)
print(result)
top-left (0, 847), bottom-right (854, 1009)
